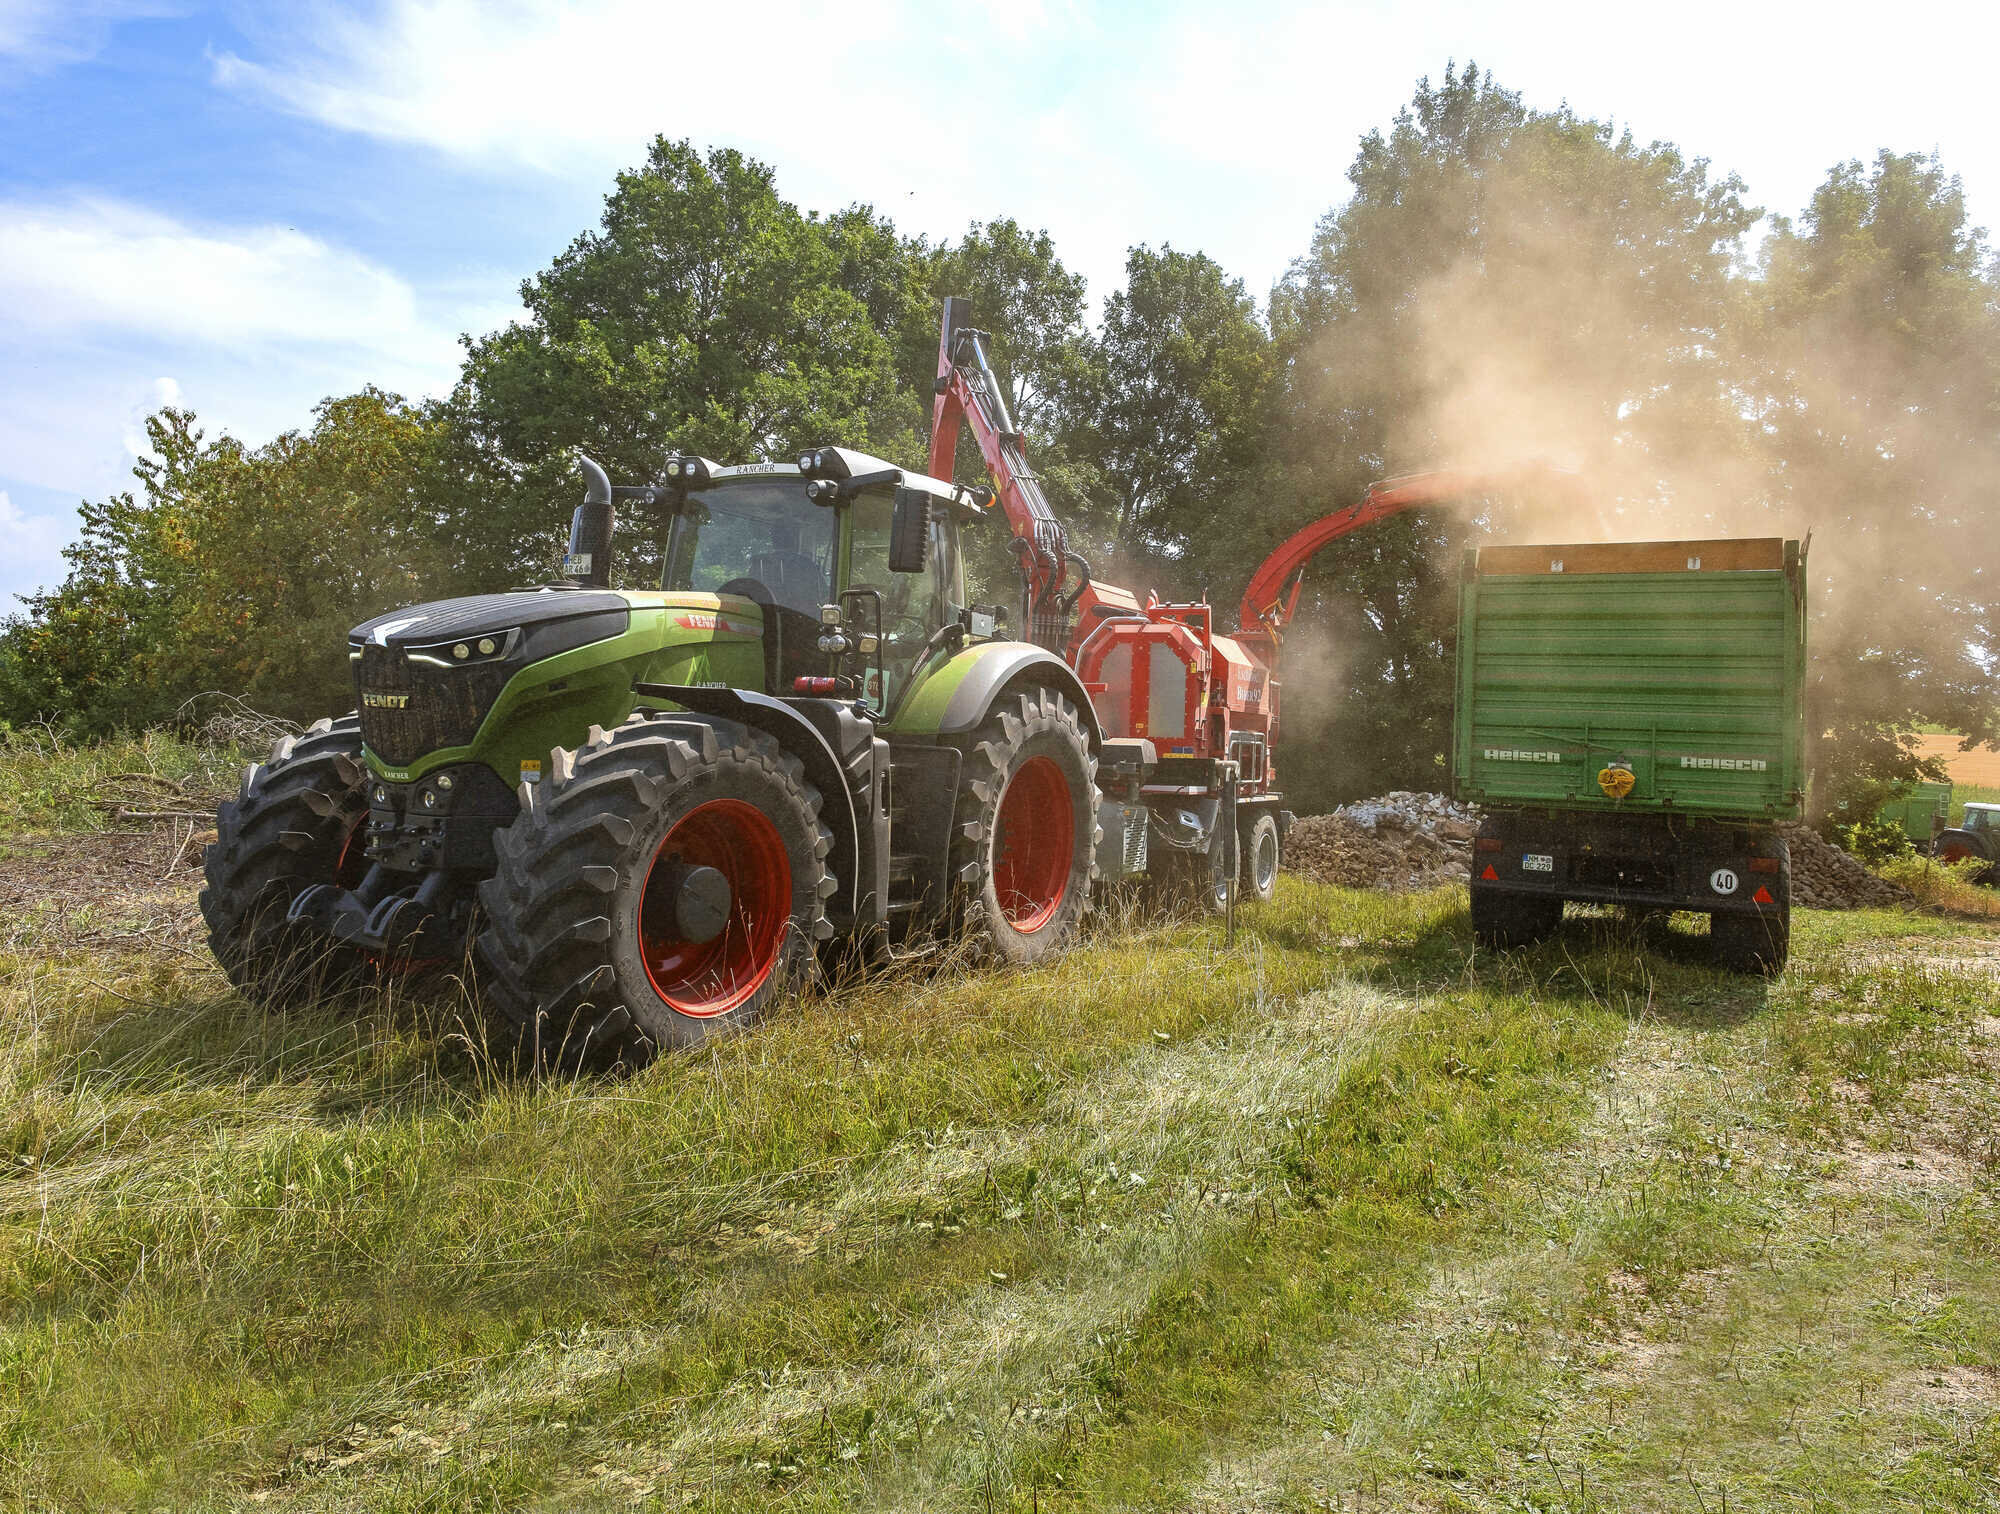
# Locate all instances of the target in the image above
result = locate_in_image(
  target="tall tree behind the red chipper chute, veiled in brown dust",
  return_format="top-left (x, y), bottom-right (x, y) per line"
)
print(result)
top-left (1234, 66), bottom-right (1758, 800)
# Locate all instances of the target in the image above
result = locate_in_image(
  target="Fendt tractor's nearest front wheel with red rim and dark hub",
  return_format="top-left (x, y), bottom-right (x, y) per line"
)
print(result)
top-left (474, 714), bottom-right (836, 1068)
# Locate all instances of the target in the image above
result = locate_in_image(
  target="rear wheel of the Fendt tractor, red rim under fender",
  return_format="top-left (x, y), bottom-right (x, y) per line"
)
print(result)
top-left (950, 688), bottom-right (1098, 966)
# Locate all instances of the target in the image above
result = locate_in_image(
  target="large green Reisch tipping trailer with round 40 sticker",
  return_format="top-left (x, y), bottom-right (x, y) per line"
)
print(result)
top-left (1452, 538), bottom-right (1806, 970)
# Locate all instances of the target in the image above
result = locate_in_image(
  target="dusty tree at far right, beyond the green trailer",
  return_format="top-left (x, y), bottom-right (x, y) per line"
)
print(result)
top-left (1750, 152), bottom-right (2000, 810)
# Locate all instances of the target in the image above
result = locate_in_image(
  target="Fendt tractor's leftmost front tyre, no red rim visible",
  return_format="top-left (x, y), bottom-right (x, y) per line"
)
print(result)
top-left (202, 716), bottom-right (368, 1008)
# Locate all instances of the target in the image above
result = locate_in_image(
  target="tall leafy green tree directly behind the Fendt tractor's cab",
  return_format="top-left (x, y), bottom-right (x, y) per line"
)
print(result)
top-left (450, 138), bottom-right (922, 580)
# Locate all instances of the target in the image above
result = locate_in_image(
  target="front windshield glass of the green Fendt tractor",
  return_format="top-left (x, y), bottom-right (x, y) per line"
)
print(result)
top-left (660, 474), bottom-right (838, 616)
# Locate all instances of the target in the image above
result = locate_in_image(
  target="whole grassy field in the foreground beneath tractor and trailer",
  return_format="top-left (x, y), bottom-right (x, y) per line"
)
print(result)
top-left (0, 728), bottom-right (2000, 1514)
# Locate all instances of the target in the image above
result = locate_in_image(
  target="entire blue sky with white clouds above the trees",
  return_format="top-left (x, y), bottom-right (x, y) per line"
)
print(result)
top-left (0, 0), bottom-right (2000, 604)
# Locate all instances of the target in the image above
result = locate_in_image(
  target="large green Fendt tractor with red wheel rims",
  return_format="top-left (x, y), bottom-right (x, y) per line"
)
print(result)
top-left (202, 448), bottom-right (1102, 1064)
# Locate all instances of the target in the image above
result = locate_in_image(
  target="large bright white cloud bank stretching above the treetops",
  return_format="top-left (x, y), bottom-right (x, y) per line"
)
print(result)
top-left (216, 0), bottom-right (2000, 312)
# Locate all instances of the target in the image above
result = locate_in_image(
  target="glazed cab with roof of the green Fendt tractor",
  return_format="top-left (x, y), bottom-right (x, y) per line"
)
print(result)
top-left (660, 448), bottom-right (980, 716)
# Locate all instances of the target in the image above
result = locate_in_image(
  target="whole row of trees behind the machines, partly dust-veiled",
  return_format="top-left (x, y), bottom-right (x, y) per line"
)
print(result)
top-left (0, 97), bottom-right (2000, 808)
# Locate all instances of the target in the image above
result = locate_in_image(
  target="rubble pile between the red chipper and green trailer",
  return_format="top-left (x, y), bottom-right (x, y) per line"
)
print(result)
top-left (1284, 790), bottom-right (1480, 890)
